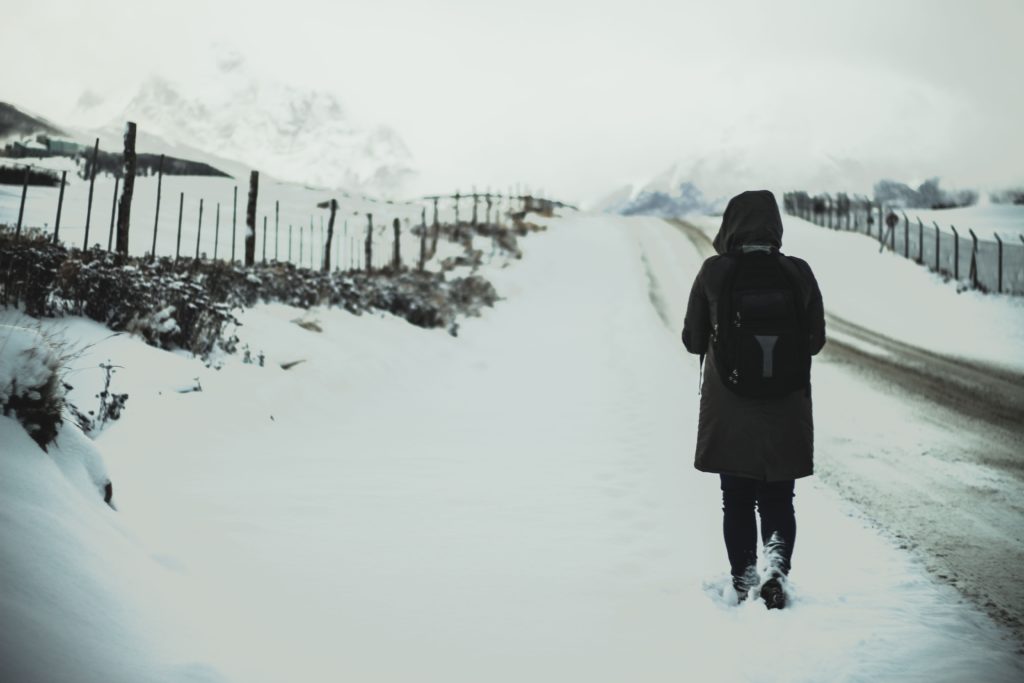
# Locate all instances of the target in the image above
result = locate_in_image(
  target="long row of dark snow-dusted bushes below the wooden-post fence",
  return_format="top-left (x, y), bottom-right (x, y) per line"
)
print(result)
top-left (0, 221), bottom-right (512, 357)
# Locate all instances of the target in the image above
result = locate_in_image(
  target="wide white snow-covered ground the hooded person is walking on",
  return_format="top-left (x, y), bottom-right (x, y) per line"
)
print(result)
top-left (0, 215), bottom-right (1024, 683)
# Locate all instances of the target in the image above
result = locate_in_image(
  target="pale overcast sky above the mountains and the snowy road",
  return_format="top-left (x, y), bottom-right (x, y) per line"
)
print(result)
top-left (0, 0), bottom-right (1024, 201)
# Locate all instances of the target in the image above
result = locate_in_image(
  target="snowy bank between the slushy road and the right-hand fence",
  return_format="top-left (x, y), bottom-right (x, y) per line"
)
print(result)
top-left (687, 214), bottom-right (1024, 373)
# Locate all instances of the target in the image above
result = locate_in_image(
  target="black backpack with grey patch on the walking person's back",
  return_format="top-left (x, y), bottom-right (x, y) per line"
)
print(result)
top-left (711, 249), bottom-right (811, 398)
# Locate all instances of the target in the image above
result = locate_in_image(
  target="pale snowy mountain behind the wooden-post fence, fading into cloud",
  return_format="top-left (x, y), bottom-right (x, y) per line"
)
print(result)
top-left (80, 53), bottom-right (414, 195)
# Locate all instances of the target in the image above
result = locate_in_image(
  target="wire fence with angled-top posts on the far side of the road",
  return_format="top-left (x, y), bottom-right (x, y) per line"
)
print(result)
top-left (783, 191), bottom-right (1024, 295)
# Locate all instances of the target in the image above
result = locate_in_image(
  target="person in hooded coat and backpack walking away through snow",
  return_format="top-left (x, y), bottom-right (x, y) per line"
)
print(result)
top-left (682, 189), bottom-right (825, 609)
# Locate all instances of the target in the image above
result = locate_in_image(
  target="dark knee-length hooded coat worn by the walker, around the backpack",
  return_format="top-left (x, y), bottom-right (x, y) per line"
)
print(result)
top-left (683, 189), bottom-right (825, 481)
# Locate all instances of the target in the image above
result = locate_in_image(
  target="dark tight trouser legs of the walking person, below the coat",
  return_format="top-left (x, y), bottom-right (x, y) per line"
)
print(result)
top-left (721, 474), bottom-right (797, 577)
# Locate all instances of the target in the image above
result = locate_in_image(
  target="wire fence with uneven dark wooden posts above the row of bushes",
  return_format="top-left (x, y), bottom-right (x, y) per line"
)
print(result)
top-left (0, 124), bottom-right (568, 270)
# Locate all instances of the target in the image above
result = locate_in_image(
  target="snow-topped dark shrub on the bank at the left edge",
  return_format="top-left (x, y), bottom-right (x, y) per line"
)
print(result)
top-left (0, 325), bottom-right (65, 450)
